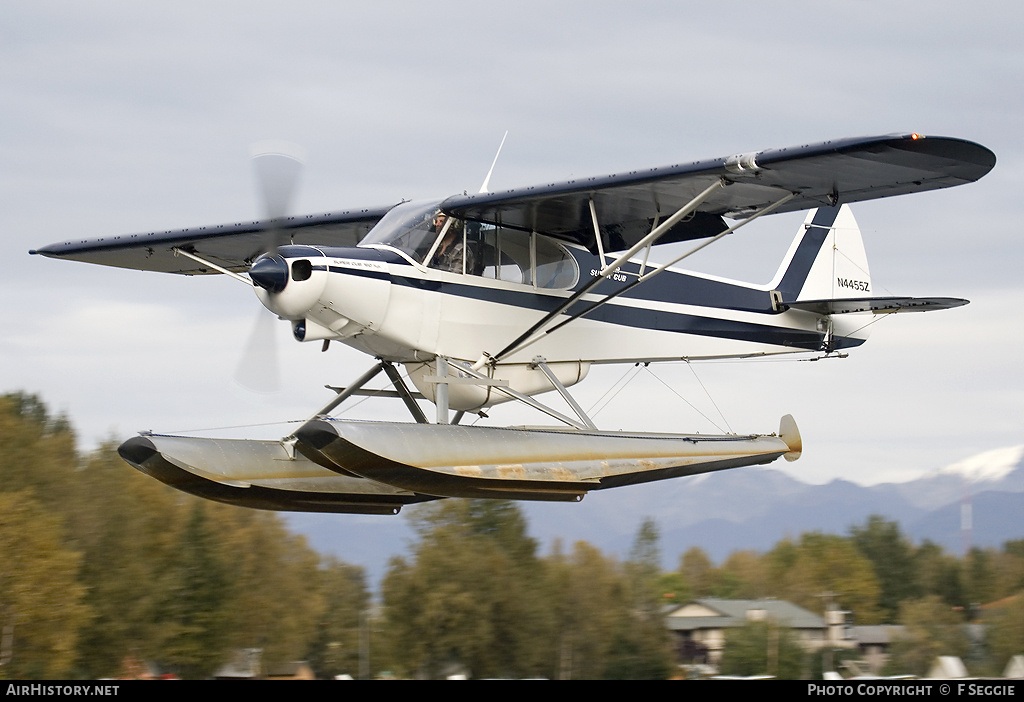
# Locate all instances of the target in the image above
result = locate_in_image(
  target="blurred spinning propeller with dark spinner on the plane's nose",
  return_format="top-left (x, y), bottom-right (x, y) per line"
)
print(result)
top-left (234, 142), bottom-right (302, 393)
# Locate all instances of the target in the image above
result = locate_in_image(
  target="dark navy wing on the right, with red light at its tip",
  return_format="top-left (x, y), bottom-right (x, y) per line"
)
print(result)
top-left (442, 134), bottom-right (995, 251)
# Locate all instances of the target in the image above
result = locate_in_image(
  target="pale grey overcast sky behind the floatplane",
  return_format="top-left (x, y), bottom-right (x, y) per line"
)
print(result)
top-left (0, 0), bottom-right (1024, 483)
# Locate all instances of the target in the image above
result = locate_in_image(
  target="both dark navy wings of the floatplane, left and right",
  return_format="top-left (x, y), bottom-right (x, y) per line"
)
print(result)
top-left (32, 134), bottom-right (995, 274)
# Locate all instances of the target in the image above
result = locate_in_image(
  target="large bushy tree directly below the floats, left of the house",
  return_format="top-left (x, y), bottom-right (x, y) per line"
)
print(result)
top-left (382, 500), bottom-right (551, 677)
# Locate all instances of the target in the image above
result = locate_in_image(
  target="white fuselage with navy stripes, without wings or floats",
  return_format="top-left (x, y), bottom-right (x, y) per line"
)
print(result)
top-left (257, 203), bottom-right (866, 408)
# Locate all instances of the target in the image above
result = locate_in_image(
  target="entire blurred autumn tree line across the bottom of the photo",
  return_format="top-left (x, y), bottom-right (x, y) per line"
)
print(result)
top-left (0, 394), bottom-right (1024, 678)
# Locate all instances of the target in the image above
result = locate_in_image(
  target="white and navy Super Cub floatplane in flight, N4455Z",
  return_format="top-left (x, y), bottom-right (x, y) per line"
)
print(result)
top-left (31, 134), bottom-right (995, 514)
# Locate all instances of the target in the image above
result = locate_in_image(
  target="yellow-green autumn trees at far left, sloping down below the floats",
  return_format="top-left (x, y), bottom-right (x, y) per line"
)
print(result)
top-left (0, 394), bottom-right (370, 678)
